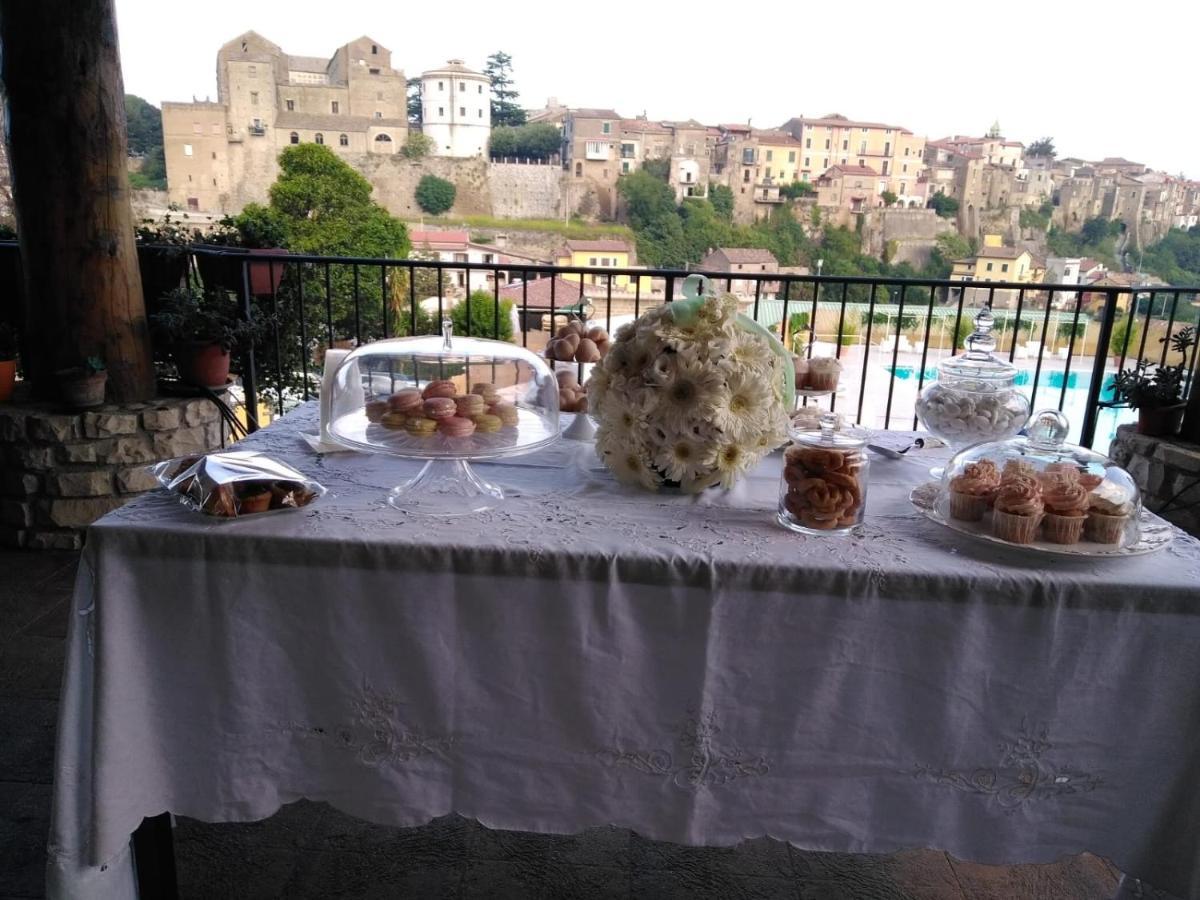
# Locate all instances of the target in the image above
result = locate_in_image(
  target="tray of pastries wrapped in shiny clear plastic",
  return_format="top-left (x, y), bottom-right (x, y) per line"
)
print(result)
top-left (150, 450), bottom-right (325, 518)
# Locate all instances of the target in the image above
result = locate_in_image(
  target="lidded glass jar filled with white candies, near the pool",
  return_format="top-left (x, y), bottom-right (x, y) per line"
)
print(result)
top-left (917, 307), bottom-right (1030, 448)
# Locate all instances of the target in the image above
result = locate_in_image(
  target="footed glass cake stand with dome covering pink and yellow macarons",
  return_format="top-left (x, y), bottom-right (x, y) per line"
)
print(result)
top-left (329, 319), bottom-right (559, 515)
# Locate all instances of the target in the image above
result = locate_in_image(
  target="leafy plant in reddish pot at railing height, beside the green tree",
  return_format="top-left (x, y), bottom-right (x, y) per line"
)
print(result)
top-left (196, 203), bottom-right (288, 296)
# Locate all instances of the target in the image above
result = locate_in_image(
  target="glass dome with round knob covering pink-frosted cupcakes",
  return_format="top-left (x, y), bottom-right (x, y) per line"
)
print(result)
top-left (937, 409), bottom-right (1141, 556)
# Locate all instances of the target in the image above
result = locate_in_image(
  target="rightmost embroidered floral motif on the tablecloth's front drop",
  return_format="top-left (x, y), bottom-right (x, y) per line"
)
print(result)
top-left (912, 722), bottom-right (1104, 815)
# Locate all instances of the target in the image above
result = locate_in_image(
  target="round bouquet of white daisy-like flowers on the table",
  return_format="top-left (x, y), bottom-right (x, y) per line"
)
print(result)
top-left (588, 276), bottom-right (793, 493)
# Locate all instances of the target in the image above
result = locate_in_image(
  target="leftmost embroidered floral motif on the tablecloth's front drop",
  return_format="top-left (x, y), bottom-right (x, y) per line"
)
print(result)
top-left (278, 683), bottom-right (454, 766)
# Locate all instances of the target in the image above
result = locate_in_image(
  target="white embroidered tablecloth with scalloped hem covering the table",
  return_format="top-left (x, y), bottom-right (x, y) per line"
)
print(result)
top-left (49, 404), bottom-right (1200, 898)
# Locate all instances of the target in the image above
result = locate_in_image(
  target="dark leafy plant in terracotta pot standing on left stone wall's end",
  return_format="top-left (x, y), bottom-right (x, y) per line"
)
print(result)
top-left (151, 286), bottom-right (262, 388)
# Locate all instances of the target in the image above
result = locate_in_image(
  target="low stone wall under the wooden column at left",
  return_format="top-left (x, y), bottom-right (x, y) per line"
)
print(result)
top-left (0, 398), bottom-right (224, 550)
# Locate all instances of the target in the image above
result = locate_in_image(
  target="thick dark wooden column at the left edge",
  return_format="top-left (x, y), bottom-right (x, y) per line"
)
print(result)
top-left (0, 0), bottom-right (155, 402)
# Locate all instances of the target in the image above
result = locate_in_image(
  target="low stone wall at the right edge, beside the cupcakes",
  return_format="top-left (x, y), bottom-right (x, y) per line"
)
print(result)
top-left (1109, 425), bottom-right (1200, 538)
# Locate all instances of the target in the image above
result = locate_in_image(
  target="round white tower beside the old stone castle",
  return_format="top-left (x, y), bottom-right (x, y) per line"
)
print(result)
top-left (421, 59), bottom-right (492, 156)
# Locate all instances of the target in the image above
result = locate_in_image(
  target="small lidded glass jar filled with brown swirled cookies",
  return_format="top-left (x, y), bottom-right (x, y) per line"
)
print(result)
top-left (776, 413), bottom-right (869, 534)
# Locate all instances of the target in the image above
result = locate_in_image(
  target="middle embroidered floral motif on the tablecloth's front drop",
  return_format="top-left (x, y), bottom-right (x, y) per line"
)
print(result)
top-left (595, 710), bottom-right (769, 791)
